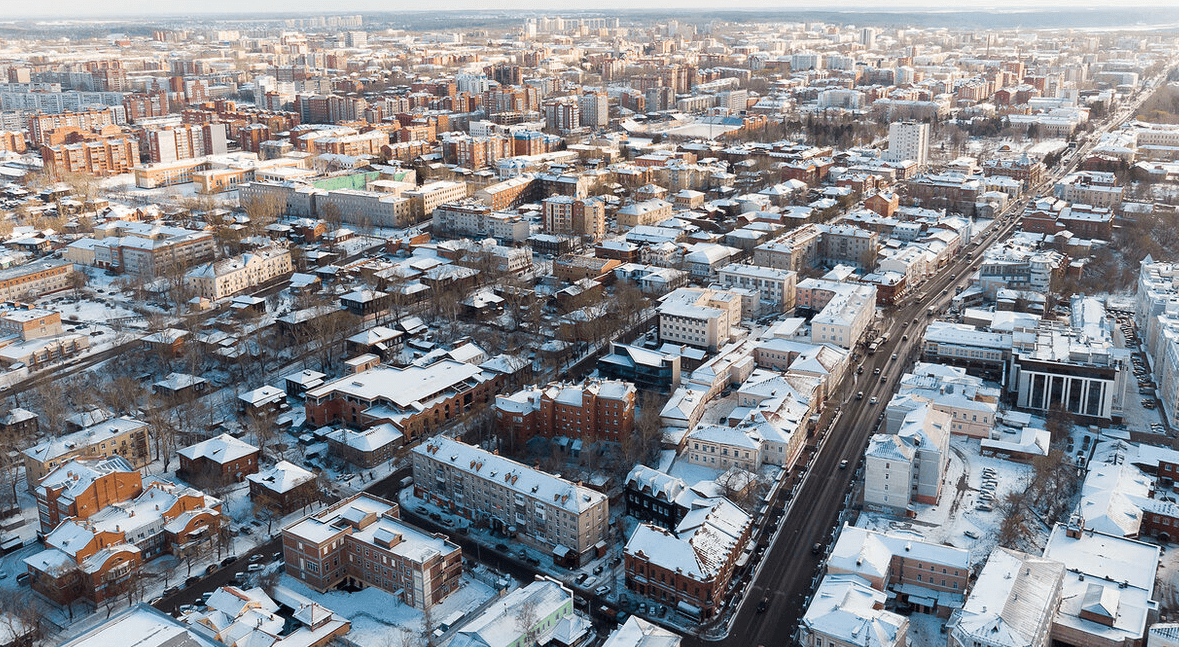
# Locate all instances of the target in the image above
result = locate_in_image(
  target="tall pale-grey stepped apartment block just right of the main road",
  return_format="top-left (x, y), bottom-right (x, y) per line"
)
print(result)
top-left (863, 405), bottom-right (951, 515)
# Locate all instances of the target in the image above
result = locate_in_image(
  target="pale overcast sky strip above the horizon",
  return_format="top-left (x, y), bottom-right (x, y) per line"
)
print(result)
top-left (13, 0), bottom-right (1174, 20)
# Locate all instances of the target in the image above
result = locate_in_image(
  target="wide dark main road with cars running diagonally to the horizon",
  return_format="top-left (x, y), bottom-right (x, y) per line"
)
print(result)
top-left (684, 66), bottom-right (1169, 647)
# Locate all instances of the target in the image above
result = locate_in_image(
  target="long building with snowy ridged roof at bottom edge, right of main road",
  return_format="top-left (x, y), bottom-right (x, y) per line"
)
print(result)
top-left (947, 547), bottom-right (1065, 647)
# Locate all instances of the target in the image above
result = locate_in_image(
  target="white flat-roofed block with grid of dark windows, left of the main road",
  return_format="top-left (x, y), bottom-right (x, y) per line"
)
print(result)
top-left (658, 288), bottom-right (742, 351)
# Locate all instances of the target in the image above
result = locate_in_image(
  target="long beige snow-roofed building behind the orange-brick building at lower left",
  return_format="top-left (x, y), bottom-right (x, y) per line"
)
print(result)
top-left (21, 416), bottom-right (151, 491)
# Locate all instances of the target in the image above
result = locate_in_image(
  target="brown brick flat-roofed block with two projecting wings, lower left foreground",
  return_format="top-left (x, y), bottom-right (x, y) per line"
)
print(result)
top-left (283, 493), bottom-right (462, 609)
